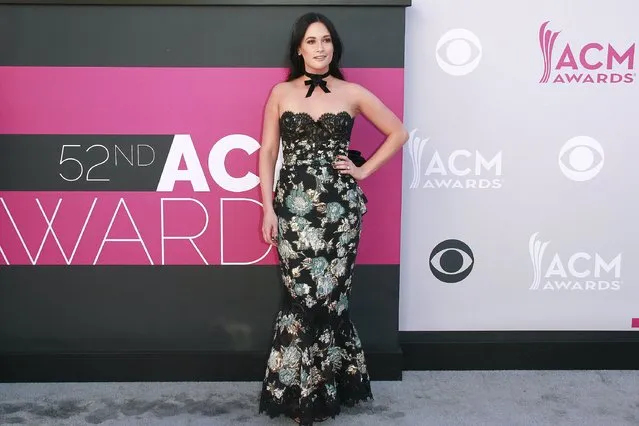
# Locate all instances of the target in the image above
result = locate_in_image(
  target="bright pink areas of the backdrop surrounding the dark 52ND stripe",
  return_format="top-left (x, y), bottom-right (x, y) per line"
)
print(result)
top-left (0, 67), bottom-right (403, 265)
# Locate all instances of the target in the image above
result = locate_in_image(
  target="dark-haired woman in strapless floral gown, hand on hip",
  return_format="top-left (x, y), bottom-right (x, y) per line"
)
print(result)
top-left (259, 13), bottom-right (408, 425)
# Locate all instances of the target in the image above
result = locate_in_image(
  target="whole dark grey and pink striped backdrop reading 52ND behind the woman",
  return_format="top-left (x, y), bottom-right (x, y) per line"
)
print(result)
top-left (0, 1), bottom-right (405, 362)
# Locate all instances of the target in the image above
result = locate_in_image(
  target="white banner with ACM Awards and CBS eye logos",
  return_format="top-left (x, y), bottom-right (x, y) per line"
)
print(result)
top-left (400, 0), bottom-right (639, 331)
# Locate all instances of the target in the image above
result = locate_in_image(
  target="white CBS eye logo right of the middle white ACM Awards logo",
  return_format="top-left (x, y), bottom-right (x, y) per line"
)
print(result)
top-left (558, 136), bottom-right (604, 182)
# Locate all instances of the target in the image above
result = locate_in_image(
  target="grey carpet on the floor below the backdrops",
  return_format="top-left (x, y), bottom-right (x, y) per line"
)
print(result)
top-left (0, 371), bottom-right (639, 426)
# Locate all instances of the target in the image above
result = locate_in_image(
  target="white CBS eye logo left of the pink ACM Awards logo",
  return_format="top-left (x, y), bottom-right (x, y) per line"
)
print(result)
top-left (435, 28), bottom-right (482, 76)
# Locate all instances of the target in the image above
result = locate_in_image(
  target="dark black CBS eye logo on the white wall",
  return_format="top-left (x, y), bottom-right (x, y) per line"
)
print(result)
top-left (429, 240), bottom-right (475, 283)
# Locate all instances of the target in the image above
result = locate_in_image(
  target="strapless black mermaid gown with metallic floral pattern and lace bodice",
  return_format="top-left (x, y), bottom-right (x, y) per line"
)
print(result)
top-left (259, 111), bottom-right (373, 425)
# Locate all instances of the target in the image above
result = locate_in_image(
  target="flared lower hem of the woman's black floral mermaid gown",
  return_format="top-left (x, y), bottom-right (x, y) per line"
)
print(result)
top-left (259, 301), bottom-right (373, 425)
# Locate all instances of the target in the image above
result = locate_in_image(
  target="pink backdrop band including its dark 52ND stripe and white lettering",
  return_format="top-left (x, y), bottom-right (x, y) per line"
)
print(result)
top-left (0, 66), bottom-right (403, 266)
